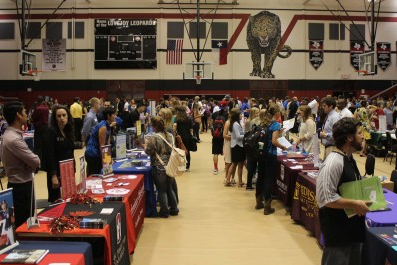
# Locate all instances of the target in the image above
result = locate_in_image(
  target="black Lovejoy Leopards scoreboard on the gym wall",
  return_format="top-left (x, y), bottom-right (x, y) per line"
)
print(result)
top-left (95, 19), bottom-right (157, 69)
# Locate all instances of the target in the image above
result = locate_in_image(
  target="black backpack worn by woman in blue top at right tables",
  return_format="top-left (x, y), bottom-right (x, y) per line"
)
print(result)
top-left (243, 122), bottom-right (268, 161)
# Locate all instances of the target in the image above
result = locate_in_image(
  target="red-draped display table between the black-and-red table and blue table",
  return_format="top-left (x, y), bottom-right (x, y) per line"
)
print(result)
top-left (87, 174), bottom-right (145, 253)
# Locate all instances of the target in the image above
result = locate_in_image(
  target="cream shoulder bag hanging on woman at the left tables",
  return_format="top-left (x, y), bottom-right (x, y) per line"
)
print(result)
top-left (156, 133), bottom-right (187, 178)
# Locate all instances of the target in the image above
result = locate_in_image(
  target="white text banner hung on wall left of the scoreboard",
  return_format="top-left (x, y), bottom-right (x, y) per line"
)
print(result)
top-left (41, 39), bottom-right (66, 71)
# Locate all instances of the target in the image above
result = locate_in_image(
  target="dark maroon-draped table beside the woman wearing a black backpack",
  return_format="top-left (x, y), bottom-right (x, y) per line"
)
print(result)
top-left (274, 155), bottom-right (315, 207)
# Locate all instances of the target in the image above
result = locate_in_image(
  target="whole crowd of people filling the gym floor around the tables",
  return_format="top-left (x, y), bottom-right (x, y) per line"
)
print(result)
top-left (1, 92), bottom-right (397, 264)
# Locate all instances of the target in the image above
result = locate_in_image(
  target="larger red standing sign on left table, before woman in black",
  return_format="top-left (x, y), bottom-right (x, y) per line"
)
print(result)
top-left (59, 158), bottom-right (77, 200)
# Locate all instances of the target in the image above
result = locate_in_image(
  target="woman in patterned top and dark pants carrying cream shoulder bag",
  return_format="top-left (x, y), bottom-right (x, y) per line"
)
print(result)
top-left (143, 116), bottom-right (179, 218)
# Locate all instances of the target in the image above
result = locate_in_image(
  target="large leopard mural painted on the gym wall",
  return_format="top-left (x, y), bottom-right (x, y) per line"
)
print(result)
top-left (247, 11), bottom-right (292, 78)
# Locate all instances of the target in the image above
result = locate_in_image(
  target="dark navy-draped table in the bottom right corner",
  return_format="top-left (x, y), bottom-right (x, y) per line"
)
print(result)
top-left (363, 227), bottom-right (397, 265)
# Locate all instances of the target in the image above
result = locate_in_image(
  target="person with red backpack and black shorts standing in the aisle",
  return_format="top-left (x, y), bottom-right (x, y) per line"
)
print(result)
top-left (211, 101), bottom-right (228, 175)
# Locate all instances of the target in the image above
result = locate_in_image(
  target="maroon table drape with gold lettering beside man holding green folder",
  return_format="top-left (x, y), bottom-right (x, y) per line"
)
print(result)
top-left (291, 170), bottom-right (323, 245)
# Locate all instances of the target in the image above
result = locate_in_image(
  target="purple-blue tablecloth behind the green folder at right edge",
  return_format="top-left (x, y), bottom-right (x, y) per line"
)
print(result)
top-left (365, 189), bottom-right (397, 227)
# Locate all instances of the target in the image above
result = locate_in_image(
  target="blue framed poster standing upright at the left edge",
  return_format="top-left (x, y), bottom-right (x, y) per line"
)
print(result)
top-left (0, 189), bottom-right (19, 254)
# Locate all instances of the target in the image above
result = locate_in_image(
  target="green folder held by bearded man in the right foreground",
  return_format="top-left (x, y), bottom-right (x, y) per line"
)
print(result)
top-left (339, 177), bottom-right (387, 217)
